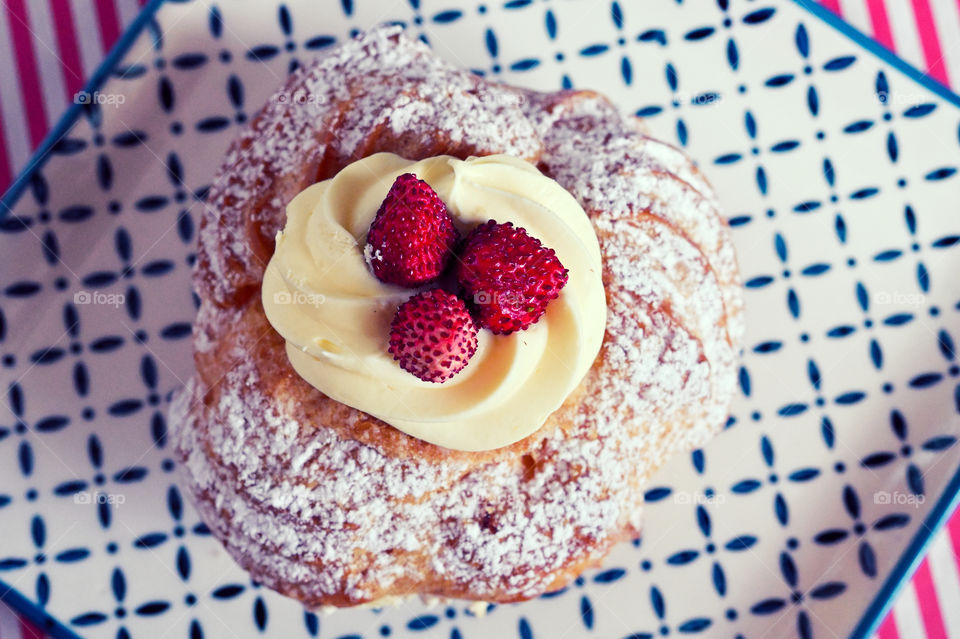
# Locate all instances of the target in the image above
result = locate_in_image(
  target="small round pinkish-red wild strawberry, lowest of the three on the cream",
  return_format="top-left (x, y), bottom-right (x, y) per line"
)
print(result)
top-left (389, 288), bottom-right (477, 382)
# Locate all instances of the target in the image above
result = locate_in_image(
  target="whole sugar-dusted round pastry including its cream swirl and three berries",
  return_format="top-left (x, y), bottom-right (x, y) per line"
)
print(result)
top-left (171, 27), bottom-right (743, 607)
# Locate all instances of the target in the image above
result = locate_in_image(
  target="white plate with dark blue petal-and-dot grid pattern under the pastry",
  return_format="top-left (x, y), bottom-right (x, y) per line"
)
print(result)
top-left (0, 0), bottom-right (960, 639)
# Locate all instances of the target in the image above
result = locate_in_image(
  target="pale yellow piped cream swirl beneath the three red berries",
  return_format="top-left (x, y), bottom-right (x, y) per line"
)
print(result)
top-left (262, 153), bottom-right (607, 451)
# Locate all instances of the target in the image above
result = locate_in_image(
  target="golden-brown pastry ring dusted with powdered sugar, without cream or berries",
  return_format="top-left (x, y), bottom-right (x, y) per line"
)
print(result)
top-left (171, 29), bottom-right (743, 606)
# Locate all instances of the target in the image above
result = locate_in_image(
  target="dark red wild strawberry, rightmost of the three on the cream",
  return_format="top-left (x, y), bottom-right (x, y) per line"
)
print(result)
top-left (457, 220), bottom-right (567, 335)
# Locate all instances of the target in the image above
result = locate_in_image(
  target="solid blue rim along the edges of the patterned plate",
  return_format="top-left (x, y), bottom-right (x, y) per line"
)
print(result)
top-left (0, 0), bottom-right (960, 639)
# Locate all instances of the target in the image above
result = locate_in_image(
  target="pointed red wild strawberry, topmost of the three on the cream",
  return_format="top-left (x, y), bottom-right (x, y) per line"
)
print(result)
top-left (364, 173), bottom-right (458, 288)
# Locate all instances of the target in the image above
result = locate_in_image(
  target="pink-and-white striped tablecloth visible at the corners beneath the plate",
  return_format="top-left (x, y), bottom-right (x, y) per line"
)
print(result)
top-left (0, 0), bottom-right (960, 639)
